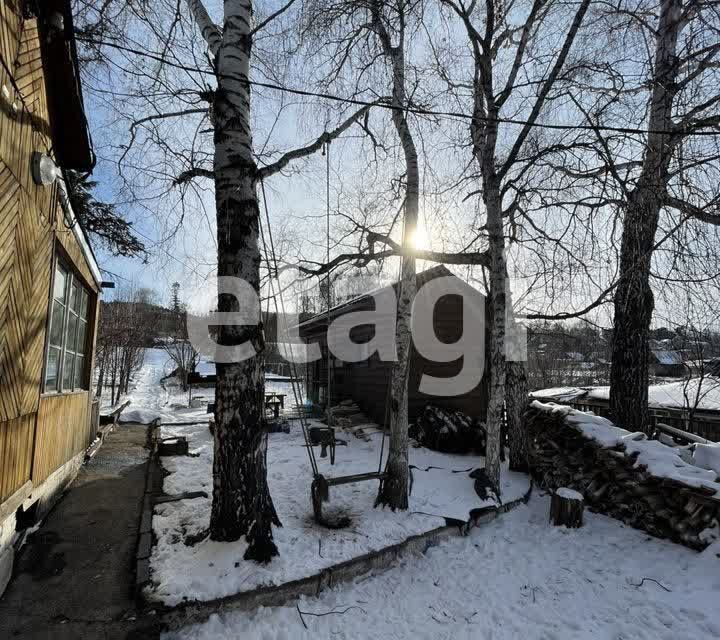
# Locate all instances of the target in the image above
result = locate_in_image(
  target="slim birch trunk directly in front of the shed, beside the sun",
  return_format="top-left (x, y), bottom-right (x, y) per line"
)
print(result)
top-left (373, 2), bottom-right (420, 511)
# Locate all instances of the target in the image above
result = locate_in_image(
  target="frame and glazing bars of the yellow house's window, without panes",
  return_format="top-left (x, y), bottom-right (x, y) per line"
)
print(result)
top-left (41, 252), bottom-right (95, 395)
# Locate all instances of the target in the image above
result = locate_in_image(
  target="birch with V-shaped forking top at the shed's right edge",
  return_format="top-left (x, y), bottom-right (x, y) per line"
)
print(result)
top-left (441, 0), bottom-right (590, 485)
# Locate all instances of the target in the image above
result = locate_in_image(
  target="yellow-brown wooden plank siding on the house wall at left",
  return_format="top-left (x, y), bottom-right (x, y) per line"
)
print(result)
top-left (0, 0), bottom-right (98, 503)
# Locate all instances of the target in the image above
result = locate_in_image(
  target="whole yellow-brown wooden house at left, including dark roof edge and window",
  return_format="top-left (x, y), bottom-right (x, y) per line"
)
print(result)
top-left (0, 0), bottom-right (101, 593)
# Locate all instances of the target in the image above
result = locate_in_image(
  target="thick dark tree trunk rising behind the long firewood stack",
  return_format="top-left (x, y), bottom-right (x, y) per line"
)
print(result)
top-left (610, 0), bottom-right (682, 433)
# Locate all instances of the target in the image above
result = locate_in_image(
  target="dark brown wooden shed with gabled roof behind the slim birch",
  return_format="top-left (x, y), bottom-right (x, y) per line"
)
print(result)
top-left (299, 266), bottom-right (488, 424)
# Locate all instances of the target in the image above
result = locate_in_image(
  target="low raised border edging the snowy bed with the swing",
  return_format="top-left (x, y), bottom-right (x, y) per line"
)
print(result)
top-left (150, 482), bottom-right (533, 630)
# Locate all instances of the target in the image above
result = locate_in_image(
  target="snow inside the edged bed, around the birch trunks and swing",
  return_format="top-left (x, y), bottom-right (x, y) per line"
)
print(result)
top-left (114, 350), bottom-right (529, 605)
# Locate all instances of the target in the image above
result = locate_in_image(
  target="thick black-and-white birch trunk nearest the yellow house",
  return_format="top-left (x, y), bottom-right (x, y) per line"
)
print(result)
top-left (200, 0), bottom-right (280, 562)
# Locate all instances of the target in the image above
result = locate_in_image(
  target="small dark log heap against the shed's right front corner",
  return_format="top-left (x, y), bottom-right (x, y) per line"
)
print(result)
top-left (409, 405), bottom-right (485, 455)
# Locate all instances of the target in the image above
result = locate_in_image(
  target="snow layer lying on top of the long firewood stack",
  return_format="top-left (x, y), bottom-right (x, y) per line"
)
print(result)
top-left (532, 400), bottom-right (720, 496)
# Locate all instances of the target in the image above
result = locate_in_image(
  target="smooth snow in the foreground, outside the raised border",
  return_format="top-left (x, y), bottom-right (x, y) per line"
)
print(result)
top-left (164, 496), bottom-right (720, 640)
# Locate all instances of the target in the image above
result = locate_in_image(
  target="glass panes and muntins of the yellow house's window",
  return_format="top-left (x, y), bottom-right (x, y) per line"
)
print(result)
top-left (45, 262), bottom-right (90, 392)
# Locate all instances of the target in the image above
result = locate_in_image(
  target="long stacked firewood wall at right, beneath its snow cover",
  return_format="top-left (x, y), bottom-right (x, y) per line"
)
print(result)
top-left (525, 404), bottom-right (720, 550)
